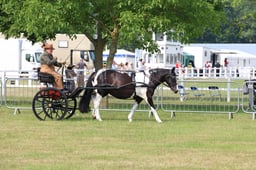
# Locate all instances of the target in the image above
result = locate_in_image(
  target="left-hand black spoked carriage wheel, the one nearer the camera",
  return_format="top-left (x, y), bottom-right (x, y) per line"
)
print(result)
top-left (32, 88), bottom-right (68, 120)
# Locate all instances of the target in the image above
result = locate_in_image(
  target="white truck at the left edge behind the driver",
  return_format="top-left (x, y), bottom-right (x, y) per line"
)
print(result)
top-left (0, 38), bottom-right (43, 75)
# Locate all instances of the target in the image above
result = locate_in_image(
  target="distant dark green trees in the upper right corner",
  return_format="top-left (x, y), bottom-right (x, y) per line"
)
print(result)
top-left (194, 0), bottom-right (256, 43)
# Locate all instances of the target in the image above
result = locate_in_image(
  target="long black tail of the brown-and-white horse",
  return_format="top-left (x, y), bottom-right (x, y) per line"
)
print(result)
top-left (79, 73), bottom-right (94, 113)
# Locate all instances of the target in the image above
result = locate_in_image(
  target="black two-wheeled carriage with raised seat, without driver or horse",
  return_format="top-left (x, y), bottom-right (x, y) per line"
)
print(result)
top-left (32, 67), bottom-right (83, 120)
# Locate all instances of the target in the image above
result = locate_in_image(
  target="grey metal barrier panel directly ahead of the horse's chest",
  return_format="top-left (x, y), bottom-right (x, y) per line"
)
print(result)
top-left (160, 80), bottom-right (240, 119)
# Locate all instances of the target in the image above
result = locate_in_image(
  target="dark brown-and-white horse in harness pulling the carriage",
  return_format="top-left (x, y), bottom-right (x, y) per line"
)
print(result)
top-left (79, 67), bottom-right (178, 123)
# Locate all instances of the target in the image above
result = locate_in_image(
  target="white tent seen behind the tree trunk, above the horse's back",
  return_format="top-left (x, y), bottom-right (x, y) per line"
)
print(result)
top-left (103, 49), bottom-right (135, 64)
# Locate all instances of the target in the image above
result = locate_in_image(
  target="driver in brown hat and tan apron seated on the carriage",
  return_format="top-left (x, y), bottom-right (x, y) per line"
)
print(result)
top-left (40, 43), bottom-right (66, 90)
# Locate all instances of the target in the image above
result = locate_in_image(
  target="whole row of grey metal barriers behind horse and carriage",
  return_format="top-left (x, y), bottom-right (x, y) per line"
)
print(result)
top-left (0, 69), bottom-right (256, 119)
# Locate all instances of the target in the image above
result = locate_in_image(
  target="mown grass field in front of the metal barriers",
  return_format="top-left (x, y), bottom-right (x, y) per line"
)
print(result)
top-left (0, 107), bottom-right (256, 170)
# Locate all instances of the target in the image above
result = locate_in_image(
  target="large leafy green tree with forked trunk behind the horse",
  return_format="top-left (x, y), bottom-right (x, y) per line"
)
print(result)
top-left (0, 0), bottom-right (224, 69)
